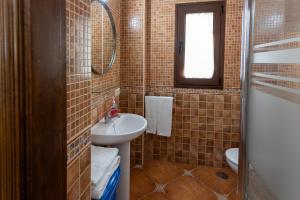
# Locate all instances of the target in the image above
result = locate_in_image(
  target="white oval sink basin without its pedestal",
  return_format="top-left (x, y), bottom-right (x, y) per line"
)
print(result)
top-left (91, 113), bottom-right (147, 145)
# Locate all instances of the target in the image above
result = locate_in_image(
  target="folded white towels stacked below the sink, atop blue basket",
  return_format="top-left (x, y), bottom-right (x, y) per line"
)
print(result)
top-left (91, 145), bottom-right (119, 185)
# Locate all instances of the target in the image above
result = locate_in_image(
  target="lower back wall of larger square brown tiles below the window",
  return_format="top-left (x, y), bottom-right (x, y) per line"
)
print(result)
top-left (144, 89), bottom-right (240, 167)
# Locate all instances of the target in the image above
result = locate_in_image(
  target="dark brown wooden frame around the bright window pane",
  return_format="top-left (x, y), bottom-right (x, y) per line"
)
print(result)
top-left (174, 1), bottom-right (226, 89)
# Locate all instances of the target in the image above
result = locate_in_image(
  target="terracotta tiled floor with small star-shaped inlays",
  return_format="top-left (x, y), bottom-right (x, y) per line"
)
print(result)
top-left (130, 161), bottom-right (237, 200)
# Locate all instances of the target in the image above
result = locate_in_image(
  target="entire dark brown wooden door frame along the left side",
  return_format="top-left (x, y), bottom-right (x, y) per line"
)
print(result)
top-left (0, 0), bottom-right (67, 200)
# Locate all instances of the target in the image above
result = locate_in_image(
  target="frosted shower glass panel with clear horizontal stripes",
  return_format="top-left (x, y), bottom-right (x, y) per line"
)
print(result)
top-left (246, 0), bottom-right (300, 200)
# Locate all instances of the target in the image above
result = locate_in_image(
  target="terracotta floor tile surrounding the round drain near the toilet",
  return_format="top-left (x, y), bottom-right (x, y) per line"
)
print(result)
top-left (193, 167), bottom-right (237, 194)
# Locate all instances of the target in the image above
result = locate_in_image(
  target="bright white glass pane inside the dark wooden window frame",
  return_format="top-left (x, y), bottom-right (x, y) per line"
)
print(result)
top-left (184, 12), bottom-right (215, 79)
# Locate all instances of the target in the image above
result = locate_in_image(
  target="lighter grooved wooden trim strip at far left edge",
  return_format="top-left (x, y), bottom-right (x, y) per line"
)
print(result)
top-left (0, 0), bottom-right (21, 200)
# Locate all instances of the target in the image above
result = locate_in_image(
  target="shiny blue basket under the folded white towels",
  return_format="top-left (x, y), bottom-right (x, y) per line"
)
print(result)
top-left (100, 167), bottom-right (121, 200)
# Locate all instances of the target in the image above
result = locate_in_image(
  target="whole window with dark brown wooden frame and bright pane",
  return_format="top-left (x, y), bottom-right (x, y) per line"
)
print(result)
top-left (174, 2), bottom-right (225, 89)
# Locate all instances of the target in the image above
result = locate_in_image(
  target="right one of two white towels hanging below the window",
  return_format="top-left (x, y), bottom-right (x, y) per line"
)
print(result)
top-left (157, 97), bottom-right (173, 137)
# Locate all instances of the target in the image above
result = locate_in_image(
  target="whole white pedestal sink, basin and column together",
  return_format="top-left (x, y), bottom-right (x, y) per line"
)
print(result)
top-left (91, 114), bottom-right (147, 200)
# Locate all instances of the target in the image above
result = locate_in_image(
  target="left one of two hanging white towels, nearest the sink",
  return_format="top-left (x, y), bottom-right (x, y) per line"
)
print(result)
top-left (145, 96), bottom-right (157, 134)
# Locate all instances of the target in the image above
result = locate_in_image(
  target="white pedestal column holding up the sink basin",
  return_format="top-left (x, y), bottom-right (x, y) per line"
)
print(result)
top-left (116, 142), bottom-right (130, 200)
